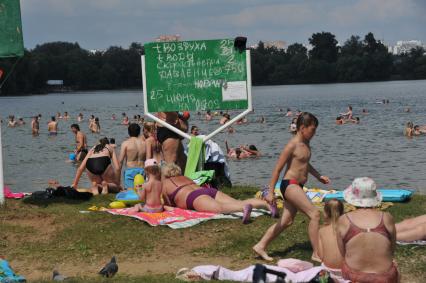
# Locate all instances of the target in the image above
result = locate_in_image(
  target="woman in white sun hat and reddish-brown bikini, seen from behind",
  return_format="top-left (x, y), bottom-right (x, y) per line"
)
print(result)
top-left (337, 177), bottom-right (399, 283)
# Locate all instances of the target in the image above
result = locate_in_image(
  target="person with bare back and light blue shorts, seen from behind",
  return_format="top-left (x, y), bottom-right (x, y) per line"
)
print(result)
top-left (119, 123), bottom-right (146, 189)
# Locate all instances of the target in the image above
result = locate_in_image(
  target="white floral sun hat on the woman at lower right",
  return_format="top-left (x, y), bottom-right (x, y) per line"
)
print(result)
top-left (343, 177), bottom-right (382, 207)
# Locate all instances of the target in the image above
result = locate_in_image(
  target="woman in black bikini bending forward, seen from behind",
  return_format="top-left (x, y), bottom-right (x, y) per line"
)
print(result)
top-left (72, 138), bottom-right (121, 195)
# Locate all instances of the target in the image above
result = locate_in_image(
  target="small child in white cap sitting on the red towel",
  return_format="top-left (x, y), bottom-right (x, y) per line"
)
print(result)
top-left (131, 159), bottom-right (168, 213)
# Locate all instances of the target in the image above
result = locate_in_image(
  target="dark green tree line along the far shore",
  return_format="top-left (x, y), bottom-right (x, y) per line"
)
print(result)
top-left (0, 32), bottom-right (426, 95)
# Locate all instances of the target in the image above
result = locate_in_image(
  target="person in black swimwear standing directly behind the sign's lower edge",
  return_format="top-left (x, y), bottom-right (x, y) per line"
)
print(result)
top-left (157, 112), bottom-right (188, 172)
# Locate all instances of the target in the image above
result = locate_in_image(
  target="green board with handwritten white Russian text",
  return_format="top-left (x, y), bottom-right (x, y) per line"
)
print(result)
top-left (144, 39), bottom-right (249, 112)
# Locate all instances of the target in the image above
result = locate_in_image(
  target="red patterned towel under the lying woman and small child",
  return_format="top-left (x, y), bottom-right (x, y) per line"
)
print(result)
top-left (105, 208), bottom-right (269, 229)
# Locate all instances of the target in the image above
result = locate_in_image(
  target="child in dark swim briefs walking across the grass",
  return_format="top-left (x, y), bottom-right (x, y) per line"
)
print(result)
top-left (253, 112), bottom-right (330, 261)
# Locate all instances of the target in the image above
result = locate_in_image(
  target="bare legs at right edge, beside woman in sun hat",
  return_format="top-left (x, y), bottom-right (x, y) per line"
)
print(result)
top-left (395, 214), bottom-right (426, 242)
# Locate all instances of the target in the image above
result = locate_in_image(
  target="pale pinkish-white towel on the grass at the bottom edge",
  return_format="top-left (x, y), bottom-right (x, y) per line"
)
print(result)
top-left (192, 265), bottom-right (323, 283)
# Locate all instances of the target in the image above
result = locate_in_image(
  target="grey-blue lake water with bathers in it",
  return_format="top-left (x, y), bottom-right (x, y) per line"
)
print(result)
top-left (0, 80), bottom-right (426, 193)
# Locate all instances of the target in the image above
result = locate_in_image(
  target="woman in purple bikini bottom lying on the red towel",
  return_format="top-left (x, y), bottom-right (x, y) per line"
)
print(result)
top-left (161, 163), bottom-right (277, 224)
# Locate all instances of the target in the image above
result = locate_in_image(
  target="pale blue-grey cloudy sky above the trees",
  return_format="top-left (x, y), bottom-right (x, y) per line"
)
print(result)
top-left (21, 0), bottom-right (426, 49)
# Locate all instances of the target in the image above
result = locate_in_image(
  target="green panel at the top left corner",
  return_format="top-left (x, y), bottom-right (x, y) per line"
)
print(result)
top-left (0, 0), bottom-right (24, 57)
